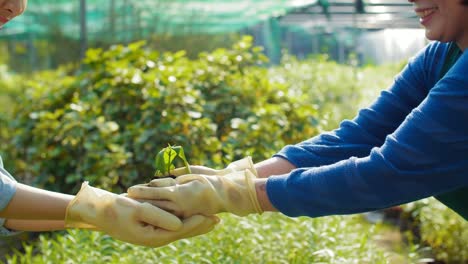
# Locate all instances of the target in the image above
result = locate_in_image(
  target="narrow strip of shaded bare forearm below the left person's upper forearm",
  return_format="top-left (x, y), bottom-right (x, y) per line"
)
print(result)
top-left (5, 219), bottom-right (65, 232)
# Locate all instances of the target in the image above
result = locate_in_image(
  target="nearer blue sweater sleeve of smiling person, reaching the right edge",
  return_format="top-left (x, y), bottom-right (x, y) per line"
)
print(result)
top-left (267, 48), bottom-right (468, 217)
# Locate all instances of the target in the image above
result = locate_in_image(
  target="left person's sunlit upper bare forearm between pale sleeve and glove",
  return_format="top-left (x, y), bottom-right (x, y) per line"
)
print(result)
top-left (0, 183), bottom-right (74, 220)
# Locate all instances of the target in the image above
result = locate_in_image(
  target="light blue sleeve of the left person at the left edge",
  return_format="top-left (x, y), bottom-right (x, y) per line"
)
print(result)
top-left (0, 157), bottom-right (20, 237)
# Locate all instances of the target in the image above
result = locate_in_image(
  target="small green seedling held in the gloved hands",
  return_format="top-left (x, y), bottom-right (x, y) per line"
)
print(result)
top-left (154, 145), bottom-right (190, 178)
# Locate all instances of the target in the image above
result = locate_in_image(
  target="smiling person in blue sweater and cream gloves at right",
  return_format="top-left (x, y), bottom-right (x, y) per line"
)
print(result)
top-left (128, 0), bottom-right (468, 226)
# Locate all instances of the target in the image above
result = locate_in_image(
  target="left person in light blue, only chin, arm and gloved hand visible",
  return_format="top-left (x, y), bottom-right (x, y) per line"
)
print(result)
top-left (0, 0), bottom-right (218, 247)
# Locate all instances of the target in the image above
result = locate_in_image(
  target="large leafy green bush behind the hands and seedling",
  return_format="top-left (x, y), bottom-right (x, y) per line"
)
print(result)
top-left (5, 37), bottom-right (370, 192)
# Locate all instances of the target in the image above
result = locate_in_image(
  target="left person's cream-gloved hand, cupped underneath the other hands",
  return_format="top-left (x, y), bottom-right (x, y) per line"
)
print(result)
top-left (65, 182), bottom-right (219, 247)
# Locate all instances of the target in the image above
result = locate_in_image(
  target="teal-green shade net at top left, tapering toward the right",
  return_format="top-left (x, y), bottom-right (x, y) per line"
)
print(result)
top-left (0, 0), bottom-right (317, 41)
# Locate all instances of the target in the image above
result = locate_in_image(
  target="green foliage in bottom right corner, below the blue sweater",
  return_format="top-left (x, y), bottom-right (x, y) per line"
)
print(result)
top-left (405, 198), bottom-right (468, 263)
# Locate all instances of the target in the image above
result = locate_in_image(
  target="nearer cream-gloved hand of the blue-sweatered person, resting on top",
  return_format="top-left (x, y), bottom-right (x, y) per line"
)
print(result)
top-left (127, 170), bottom-right (263, 217)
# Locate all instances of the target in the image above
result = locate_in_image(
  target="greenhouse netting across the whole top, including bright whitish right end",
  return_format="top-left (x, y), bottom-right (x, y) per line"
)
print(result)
top-left (0, 0), bottom-right (417, 40)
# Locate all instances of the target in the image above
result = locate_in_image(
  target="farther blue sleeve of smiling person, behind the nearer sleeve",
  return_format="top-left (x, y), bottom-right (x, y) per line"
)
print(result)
top-left (275, 43), bottom-right (446, 170)
